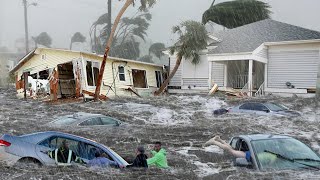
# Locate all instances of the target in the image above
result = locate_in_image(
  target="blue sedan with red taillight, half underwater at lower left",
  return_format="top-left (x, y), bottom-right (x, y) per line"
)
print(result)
top-left (0, 131), bottom-right (128, 167)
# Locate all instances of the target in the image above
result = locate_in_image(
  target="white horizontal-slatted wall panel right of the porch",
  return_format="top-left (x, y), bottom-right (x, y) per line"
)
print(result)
top-left (267, 45), bottom-right (320, 89)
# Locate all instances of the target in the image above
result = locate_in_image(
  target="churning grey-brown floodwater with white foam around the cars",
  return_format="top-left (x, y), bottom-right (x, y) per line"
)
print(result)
top-left (0, 86), bottom-right (320, 180)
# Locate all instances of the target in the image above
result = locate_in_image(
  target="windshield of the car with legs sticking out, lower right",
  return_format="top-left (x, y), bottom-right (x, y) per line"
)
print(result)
top-left (252, 138), bottom-right (320, 170)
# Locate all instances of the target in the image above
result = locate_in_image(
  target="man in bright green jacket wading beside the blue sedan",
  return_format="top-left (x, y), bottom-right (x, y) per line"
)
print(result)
top-left (147, 142), bottom-right (169, 168)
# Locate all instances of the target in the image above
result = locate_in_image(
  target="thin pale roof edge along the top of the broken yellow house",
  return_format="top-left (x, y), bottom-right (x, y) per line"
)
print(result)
top-left (10, 48), bottom-right (163, 73)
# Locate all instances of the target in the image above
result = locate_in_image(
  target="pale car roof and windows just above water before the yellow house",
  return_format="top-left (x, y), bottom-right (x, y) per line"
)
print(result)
top-left (48, 112), bottom-right (123, 127)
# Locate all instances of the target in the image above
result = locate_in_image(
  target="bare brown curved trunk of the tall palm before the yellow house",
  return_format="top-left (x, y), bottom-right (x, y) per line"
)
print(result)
top-left (94, 0), bottom-right (133, 101)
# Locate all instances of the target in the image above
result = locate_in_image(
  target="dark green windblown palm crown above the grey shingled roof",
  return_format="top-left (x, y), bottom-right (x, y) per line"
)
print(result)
top-left (202, 0), bottom-right (271, 29)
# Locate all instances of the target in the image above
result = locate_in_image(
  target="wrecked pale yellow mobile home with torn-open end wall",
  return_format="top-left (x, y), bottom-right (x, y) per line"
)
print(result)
top-left (11, 48), bottom-right (163, 100)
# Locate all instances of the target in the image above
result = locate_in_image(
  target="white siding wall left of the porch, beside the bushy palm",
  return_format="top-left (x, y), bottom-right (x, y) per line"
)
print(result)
top-left (182, 55), bottom-right (209, 89)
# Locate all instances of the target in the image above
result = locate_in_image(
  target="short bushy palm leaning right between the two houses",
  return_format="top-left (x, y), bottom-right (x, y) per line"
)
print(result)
top-left (154, 21), bottom-right (208, 95)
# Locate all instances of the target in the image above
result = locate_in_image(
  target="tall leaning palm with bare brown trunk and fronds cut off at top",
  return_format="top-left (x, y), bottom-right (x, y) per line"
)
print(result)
top-left (94, 0), bottom-right (156, 101)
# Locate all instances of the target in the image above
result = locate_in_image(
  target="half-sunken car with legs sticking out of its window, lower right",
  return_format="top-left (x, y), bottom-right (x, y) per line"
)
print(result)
top-left (230, 134), bottom-right (320, 171)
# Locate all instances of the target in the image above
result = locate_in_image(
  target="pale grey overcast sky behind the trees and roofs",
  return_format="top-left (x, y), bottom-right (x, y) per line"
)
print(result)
top-left (0, 0), bottom-right (320, 49)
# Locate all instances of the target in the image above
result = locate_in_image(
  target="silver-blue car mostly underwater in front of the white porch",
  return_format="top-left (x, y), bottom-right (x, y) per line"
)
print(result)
top-left (214, 102), bottom-right (301, 116)
